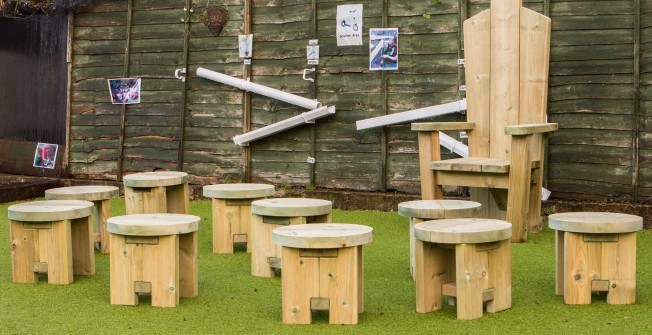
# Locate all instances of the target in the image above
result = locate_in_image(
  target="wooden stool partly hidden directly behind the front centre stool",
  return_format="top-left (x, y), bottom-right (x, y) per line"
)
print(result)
top-left (251, 198), bottom-right (333, 277)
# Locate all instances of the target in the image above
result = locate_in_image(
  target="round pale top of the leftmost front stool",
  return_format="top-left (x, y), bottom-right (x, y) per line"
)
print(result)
top-left (8, 200), bottom-right (95, 222)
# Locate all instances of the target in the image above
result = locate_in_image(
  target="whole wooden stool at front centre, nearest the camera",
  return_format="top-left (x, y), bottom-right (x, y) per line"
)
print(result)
top-left (273, 223), bottom-right (373, 325)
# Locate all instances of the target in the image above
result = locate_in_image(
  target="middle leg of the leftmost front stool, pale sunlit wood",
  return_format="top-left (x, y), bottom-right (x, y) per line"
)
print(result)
top-left (46, 220), bottom-right (73, 284)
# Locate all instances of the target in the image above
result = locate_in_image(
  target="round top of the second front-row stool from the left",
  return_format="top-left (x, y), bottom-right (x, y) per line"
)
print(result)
top-left (106, 213), bottom-right (201, 236)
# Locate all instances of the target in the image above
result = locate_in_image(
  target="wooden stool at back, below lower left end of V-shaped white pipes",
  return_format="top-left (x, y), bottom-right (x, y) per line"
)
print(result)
top-left (204, 184), bottom-right (276, 254)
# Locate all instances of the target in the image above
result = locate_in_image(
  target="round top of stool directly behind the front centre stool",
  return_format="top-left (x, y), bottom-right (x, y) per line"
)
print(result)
top-left (251, 198), bottom-right (333, 217)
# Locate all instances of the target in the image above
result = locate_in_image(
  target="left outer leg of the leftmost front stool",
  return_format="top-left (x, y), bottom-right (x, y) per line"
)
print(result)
top-left (10, 220), bottom-right (38, 283)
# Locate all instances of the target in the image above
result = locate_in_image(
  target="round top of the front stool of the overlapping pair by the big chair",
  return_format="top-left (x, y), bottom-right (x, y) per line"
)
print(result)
top-left (414, 218), bottom-right (512, 244)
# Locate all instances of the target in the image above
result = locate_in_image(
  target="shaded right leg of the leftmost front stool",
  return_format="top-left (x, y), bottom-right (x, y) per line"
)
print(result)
top-left (70, 216), bottom-right (95, 276)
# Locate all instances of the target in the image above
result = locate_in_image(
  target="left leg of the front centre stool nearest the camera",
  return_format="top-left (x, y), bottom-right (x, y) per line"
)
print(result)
top-left (281, 248), bottom-right (319, 324)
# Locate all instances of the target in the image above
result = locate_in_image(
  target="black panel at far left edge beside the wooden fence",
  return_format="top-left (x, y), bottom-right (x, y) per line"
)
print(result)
top-left (0, 15), bottom-right (68, 144)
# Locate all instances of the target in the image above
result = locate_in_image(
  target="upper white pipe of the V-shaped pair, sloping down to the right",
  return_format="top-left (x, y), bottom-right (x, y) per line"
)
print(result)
top-left (197, 67), bottom-right (321, 110)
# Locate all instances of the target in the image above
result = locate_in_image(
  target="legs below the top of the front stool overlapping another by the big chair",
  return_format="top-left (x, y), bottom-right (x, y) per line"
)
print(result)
top-left (415, 221), bottom-right (512, 320)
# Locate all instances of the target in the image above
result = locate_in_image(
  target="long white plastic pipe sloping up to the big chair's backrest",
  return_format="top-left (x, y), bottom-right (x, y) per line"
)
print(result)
top-left (355, 99), bottom-right (466, 130)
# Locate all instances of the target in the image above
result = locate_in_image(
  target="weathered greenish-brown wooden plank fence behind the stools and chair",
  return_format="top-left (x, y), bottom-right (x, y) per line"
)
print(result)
top-left (70, 0), bottom-right (652, 201)
